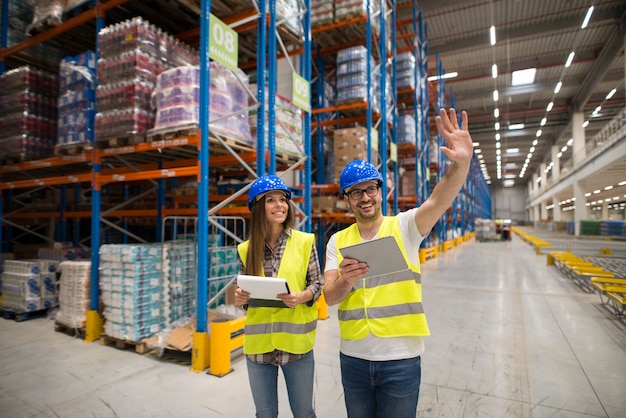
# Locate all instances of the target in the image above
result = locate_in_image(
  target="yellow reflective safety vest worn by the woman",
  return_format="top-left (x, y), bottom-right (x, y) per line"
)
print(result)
top-left (237, 230), bottom-right (317, 354)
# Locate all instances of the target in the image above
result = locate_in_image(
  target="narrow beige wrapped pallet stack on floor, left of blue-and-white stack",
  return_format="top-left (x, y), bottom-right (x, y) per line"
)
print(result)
top-left (55, 261), bottom-right (91, 329)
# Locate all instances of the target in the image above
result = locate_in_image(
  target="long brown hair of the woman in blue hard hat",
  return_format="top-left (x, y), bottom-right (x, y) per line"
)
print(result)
top-left (243, 196), bottom-right (293, 276)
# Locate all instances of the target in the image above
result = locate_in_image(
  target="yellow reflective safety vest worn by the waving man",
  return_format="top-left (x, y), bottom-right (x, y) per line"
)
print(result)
top-left (337, 216), bottom-right (430, 340)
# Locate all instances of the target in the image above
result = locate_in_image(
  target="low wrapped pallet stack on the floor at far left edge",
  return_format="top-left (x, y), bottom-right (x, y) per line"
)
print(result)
top-left (2, 260), bottom-right (59, 312)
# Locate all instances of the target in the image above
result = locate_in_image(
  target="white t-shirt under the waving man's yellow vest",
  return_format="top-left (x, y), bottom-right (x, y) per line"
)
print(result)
top-left (324, 208), bottom-right (424, 361)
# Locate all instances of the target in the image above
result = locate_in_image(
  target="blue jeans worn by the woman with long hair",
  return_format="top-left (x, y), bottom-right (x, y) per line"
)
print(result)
top-left (246, 350), bottom-right (315, 418)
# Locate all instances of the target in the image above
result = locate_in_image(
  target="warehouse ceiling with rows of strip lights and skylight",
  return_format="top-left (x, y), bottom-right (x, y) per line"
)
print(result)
top-left (398, 0), bottom-right (626, 201)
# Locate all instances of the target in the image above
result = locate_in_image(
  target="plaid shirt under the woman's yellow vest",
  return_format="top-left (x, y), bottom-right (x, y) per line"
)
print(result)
top-left (239, 229), bottom-right (322, 366)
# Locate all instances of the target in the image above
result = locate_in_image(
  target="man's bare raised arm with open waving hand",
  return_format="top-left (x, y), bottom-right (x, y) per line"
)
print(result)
top-left (415, 109), bottom-right (474, 235)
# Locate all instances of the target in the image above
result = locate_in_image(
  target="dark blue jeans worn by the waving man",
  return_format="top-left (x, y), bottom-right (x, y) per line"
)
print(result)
top-left (340, 353), bottom-right (422, 418)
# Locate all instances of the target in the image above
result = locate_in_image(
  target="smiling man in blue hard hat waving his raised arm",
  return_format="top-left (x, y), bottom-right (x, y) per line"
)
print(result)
top-left (324, 109), bottom-right (473, 418)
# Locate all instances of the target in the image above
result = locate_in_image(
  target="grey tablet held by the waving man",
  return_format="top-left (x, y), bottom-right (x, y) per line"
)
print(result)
top-left (339, 235), bottom-right (409, 278)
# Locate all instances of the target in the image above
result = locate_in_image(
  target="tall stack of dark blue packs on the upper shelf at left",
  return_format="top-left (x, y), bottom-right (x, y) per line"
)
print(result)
top-left (57, 51), bottom-right (96, 147)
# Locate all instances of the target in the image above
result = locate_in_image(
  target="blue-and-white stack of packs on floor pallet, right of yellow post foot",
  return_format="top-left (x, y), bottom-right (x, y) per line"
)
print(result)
top-left (100, 244), bottom-right (170, 341)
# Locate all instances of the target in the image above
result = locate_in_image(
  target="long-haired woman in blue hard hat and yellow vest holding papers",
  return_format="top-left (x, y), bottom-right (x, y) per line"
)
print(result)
top-left (235, 175), bottom-right (322, 418)
